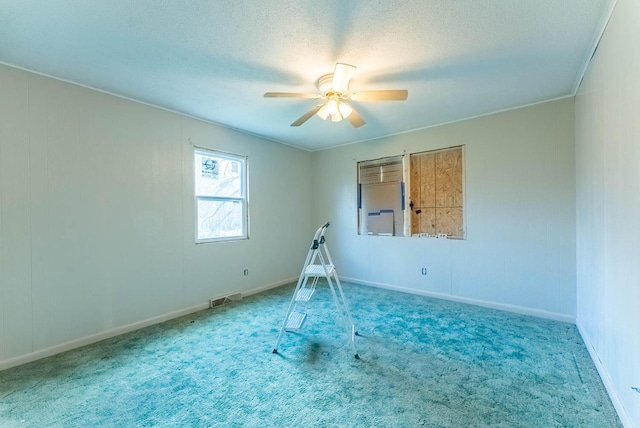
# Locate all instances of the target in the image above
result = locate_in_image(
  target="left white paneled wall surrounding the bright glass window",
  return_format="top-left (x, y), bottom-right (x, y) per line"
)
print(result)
top-left (0, 65), bottom-right (314, 369)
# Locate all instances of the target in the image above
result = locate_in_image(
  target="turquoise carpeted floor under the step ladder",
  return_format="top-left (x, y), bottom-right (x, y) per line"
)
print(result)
top-left (0, 284), bottom-right (621, 427)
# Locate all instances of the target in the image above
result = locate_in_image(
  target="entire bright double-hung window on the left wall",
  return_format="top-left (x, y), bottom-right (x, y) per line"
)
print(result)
top-left (194, 149), bottom-right (249, 242)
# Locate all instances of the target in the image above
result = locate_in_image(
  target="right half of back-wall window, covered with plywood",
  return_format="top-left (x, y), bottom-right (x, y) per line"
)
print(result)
top-left (409, 147), bottom-right (464, 239)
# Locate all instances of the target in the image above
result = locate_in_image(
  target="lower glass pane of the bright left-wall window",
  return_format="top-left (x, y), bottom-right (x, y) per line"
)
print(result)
top-left (197, 199), bottom-right (244, 239)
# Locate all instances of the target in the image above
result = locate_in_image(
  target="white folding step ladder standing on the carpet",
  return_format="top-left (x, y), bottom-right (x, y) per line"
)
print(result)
top-left (273, 222), bottom-right (360, 358)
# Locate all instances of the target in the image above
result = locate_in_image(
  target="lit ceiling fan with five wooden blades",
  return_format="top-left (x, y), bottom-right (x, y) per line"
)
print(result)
top-left (264, 63), bottom-right (409, 128)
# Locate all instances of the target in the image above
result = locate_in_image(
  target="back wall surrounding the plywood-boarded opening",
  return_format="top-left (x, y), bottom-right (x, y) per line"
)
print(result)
top-left (313, 99), bottom-right (576, 321)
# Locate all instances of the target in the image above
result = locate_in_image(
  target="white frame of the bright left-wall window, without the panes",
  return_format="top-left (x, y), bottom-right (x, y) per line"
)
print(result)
top-left (192, 146), bottom-right (249, 244)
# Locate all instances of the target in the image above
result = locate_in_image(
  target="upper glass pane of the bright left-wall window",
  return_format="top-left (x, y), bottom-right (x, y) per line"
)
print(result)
top-left (195, 152), bottom-right (244, 198)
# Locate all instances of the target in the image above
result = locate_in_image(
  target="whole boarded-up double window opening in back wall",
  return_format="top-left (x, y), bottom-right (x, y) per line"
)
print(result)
top-left (358, 146), bottom-right (465, 239)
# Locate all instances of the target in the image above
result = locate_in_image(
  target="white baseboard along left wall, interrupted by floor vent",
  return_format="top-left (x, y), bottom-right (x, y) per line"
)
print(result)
top-left (0, 278), bottom-right (297, 371)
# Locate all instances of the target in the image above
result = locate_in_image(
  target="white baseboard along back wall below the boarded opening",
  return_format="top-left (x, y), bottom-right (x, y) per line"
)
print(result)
top-left (341, 277), bottom-right (576, 324)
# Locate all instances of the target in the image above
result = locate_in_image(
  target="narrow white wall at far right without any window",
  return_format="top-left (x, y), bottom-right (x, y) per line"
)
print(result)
top-left (576, 0), bottom-right (640, 427)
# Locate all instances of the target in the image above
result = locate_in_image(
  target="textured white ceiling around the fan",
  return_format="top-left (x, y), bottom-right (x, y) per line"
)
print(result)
top-left (0, 0), bottom-right (615, 150)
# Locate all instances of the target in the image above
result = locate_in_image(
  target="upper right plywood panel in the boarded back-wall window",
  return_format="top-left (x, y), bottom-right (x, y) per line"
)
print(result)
top-left (435, 148), bottom-right (462, 207)
